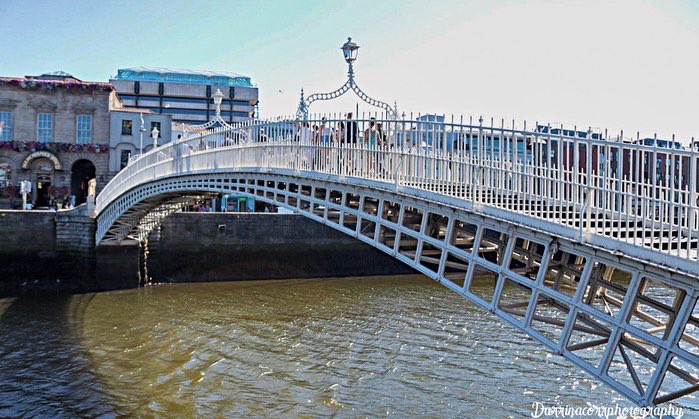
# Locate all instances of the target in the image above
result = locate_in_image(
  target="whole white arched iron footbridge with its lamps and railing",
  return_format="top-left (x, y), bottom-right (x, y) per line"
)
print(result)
top-left (96, 38), bottom-right (699, 406)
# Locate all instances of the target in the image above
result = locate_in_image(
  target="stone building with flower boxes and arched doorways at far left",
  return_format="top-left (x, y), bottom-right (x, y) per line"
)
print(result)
top-left (0, 72), bottom-right (118, 208)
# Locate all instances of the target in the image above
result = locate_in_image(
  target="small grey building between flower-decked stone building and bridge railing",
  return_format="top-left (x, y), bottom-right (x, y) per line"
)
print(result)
top-left (109, 107), bottom-right (173, 177)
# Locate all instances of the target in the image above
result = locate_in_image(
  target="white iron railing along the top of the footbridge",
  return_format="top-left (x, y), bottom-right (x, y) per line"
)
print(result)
top-left (97, 114), bottom-right (699, 261)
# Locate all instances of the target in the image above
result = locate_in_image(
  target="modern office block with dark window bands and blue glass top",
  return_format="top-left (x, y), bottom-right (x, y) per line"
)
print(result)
top-left (110, 67), bottom-right (258, 125)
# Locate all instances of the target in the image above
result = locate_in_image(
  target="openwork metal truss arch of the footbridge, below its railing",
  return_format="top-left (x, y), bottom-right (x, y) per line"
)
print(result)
top-left (98, 170), bottom-right (699, 406)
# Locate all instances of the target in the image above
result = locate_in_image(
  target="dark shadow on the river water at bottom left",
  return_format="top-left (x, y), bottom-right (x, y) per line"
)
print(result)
top-left (0, 295), bottom-right (118, 417)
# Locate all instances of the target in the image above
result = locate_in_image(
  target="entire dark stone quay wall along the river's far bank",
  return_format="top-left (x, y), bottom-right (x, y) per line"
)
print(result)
top-left (0, 212), bottom-right (414, 297)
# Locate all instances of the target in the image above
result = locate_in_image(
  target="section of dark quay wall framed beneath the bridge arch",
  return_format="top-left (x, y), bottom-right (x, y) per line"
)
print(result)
top-left (148, 213), bottom-right (414, 282)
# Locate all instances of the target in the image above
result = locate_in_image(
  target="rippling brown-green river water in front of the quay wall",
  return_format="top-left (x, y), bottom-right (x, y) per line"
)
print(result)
top-left (0, 275), bottom-right (680, 417)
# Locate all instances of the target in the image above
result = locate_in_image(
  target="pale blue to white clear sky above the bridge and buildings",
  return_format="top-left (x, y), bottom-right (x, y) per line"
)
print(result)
top-left (0, 0), bottom-right (699, 143)
